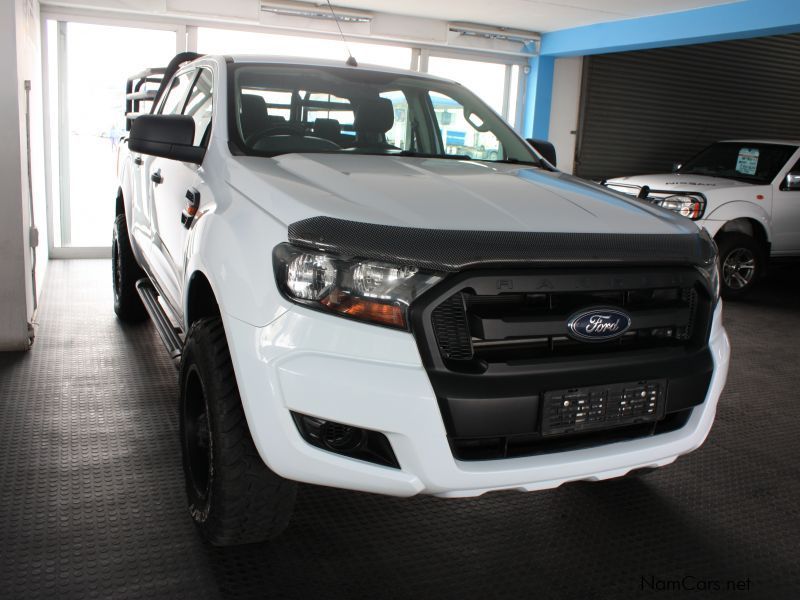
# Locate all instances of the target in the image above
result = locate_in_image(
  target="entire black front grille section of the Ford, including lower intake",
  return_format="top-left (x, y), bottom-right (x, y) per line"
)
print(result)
top-left (411, 267), bottom-right (713, 460)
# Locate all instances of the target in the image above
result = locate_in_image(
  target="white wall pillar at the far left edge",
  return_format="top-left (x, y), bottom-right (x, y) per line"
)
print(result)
top-left (0, 0), bottom-right (48, 350)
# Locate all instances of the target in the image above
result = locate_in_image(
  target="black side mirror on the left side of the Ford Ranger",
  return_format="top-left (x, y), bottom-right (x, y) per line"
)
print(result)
top-left (128, 115), bottom-right (206, 165)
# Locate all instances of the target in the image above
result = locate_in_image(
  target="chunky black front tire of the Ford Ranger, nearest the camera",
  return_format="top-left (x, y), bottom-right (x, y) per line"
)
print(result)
top-left (180, 317), bottom-right (297, 546)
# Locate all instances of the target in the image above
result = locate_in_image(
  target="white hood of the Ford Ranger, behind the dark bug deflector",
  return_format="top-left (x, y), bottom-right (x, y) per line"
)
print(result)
top-left (228, 153), bottom-right (697, 233)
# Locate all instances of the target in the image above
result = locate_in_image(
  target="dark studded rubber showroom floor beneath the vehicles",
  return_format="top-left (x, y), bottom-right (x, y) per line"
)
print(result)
top-left (0, 261), bottom-right (800, 599)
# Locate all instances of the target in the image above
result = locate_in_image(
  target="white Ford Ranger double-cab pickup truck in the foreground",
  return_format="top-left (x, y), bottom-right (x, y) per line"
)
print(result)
top-left (113, 55), bottom-right (729, 545)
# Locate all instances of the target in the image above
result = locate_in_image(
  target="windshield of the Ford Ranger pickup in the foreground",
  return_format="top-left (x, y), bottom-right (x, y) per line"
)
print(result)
top-left (230, 64), bottom-right (540, 165)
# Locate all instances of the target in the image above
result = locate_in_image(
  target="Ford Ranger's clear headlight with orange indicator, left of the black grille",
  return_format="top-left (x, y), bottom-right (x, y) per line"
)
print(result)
top-left (273, 244), bottom-right (442, 329)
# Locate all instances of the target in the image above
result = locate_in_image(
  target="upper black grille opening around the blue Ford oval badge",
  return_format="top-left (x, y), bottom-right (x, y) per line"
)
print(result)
top-left (432, 276), bottom-right (698, 370)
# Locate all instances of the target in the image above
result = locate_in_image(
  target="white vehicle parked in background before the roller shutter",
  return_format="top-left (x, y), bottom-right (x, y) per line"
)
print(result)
top-left (605, 140), bottom-right (800, 299)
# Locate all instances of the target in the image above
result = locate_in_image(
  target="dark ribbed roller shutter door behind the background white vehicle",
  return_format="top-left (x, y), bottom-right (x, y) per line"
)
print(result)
top-left (576, 34), bottom-right (800, 179)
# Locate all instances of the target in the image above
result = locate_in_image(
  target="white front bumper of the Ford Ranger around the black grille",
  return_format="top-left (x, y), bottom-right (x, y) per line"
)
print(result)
top-left (223, 303), bottom-right (730, 497)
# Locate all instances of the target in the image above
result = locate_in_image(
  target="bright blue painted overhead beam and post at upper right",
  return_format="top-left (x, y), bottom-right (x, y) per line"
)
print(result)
top-left (523, 0), bottom-right (800, 139)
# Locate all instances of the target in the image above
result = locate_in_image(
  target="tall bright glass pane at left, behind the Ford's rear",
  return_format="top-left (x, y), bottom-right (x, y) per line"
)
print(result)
top-left (53, 21), bottom-right (175, 247)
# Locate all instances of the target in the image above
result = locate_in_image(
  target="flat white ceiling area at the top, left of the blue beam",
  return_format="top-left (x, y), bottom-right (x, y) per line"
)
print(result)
top-left (313, 0), bottom-right (732, 32)
